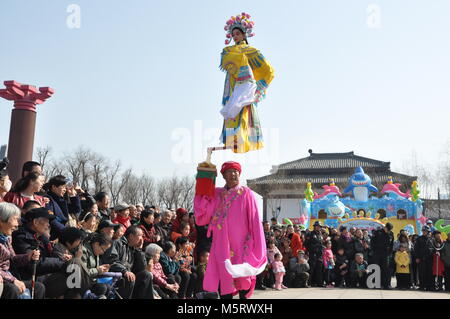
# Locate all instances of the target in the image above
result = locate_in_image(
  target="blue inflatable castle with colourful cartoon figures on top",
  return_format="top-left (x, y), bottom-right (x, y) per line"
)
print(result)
top-left (300, 171), bottom-right (428, 234)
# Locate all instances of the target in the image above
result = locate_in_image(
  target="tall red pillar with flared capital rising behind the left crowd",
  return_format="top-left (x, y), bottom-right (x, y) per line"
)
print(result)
top-left (0, 81), bottom-right (54, 183)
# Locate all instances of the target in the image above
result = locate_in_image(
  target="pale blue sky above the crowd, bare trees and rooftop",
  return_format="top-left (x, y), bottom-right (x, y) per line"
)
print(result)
top-left (0, 0), bottom-right (450, 190)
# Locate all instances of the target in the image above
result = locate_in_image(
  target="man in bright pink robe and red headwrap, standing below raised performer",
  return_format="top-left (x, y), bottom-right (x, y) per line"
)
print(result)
top-left (194, 162), bottom-right (267, 298)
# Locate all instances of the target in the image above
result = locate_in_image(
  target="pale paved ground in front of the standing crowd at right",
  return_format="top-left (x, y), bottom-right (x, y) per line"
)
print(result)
top-left (252, 288), bottom-right (450, 299)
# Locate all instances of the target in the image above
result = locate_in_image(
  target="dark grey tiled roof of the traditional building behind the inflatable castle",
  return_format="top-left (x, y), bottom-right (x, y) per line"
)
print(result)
top-left (247, 150), bottom-right (417, 197)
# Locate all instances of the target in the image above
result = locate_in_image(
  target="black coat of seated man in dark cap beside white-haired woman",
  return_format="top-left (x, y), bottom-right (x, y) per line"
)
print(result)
top-left (12, 226), bottom-right (66, 280)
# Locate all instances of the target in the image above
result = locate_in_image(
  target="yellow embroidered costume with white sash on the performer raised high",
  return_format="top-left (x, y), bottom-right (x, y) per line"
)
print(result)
top-left (220, 41), bottom-right (274, 153)
